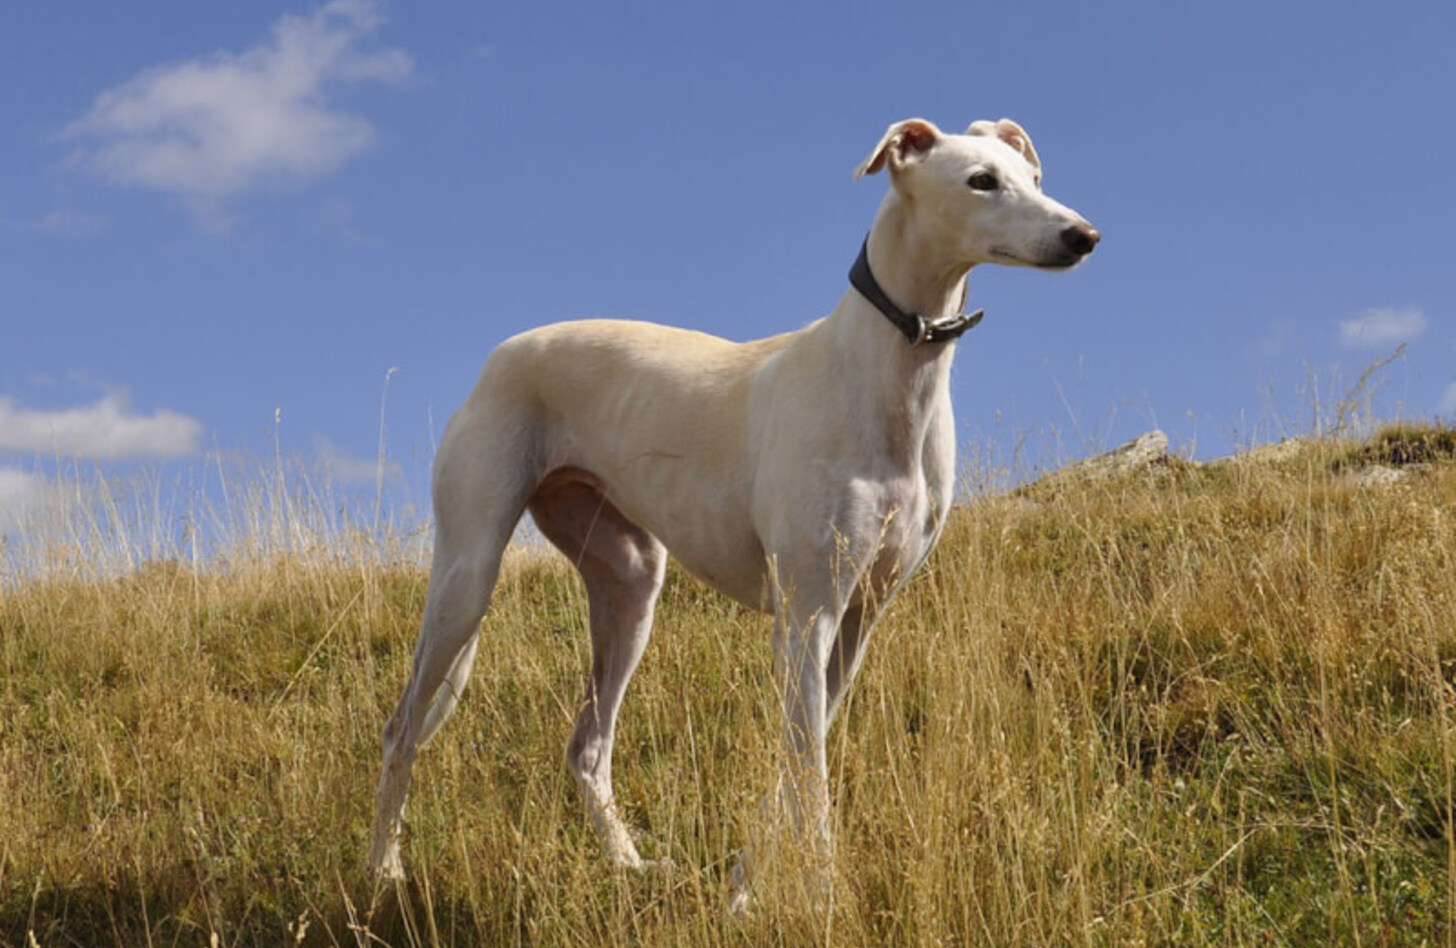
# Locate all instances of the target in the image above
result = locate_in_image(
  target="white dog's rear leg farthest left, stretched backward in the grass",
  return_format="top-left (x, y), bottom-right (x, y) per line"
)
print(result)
top-left (370, 416), bottom-right (534, 878)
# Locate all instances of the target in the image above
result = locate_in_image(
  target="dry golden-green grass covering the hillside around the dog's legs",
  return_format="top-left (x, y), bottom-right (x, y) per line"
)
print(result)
top-left (0, 434), bottom-right (1456, 947)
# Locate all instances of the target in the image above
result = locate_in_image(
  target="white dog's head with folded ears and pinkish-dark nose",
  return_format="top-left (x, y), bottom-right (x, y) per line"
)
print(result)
top-left (855, 118), bottom-right (1101, 269)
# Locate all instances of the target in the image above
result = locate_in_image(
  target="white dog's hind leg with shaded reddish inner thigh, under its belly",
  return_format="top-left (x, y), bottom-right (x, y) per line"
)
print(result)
top-left (530, 472), bottom-right (667, 868)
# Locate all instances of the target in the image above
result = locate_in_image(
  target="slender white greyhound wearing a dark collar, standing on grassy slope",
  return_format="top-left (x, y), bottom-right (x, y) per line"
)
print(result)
top-left (370, 119), bottom-right (1099, 900)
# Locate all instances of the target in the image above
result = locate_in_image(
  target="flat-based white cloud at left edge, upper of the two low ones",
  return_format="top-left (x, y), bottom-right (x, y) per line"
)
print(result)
top-left (0, 393), bottom-right (202, 460)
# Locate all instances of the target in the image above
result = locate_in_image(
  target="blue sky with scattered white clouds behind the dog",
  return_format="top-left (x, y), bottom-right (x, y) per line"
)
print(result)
top-left (0, 0), bottom-right (1456, 532)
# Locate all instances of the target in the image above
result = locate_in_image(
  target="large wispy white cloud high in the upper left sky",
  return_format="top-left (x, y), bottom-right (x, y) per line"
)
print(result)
top-left (63, 0), bottom-right (414, 222)
